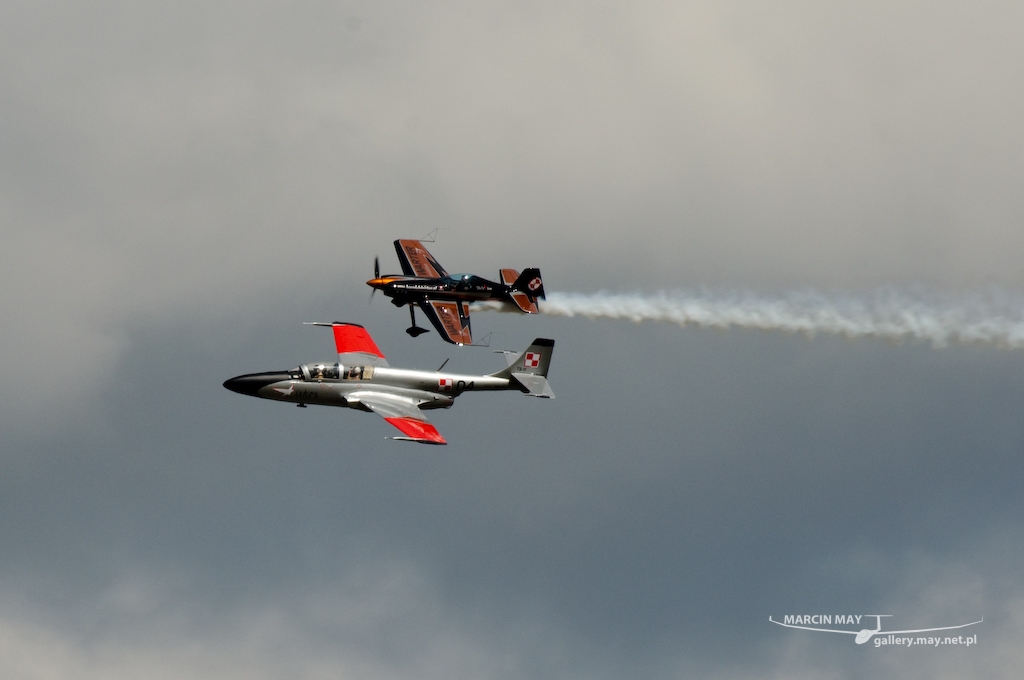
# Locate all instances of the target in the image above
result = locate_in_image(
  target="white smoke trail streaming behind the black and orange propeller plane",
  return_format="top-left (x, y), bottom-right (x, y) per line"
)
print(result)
top-left (474, 290), bottom-right (1024, 349)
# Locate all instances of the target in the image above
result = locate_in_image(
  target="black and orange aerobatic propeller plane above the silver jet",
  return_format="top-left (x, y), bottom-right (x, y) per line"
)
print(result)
top-left (367, 239), bottom-right (545, 345)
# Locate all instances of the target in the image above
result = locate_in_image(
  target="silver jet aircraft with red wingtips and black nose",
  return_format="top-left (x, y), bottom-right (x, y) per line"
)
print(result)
top-left (224, 322), bottom-right (555, 444)
